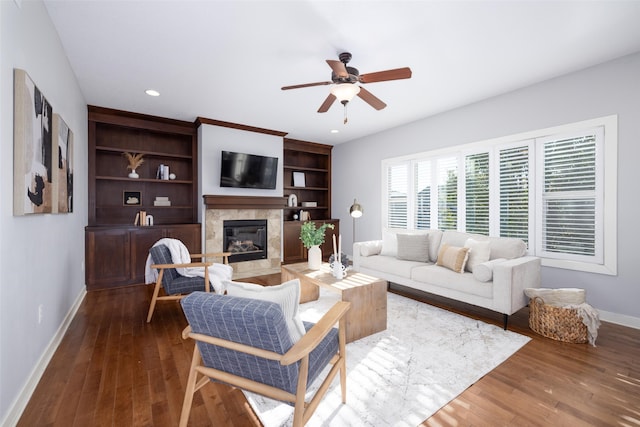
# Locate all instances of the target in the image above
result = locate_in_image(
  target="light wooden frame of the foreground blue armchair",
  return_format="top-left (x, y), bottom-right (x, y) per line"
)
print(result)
top-left (180, 301), bottom-right (351, 427)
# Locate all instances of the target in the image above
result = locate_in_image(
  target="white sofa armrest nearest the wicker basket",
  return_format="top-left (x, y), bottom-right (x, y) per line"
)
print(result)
top-left (493, 256), bottom-right (541, 314)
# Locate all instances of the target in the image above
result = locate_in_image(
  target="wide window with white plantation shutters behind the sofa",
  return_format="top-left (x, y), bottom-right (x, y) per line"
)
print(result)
top-left (383, 116), bottom-right (617, 274)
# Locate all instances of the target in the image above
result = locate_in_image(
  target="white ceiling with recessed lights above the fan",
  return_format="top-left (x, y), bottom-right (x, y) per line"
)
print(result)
top-left (45, 0), bottom-right (640, 144)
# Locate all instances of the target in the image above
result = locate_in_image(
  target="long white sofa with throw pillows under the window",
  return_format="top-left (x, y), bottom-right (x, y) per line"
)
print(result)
top-left (353, 229), bottom-right (540, 329)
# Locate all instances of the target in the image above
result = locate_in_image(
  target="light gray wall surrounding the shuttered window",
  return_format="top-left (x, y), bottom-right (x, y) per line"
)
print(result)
top-left (332, 53), bottom-right (640, 327)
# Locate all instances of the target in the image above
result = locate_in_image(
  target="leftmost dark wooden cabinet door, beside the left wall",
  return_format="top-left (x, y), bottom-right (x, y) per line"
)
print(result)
top-left (85, 229), bottom-right (131, 290)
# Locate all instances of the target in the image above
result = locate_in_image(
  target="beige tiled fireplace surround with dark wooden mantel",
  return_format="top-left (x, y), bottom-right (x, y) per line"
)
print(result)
top-left (204, 196), bottom-right (286, 280)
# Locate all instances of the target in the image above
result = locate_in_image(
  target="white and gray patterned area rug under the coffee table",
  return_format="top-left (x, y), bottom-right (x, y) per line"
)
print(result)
top-left (245, 290), bottom-right (530, 427)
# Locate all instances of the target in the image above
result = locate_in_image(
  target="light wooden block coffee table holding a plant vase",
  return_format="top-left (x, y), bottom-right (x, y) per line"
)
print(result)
top-left (281, 262), bottom-right (387, 342)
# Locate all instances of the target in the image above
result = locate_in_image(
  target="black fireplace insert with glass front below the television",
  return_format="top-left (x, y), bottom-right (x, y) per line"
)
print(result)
top-left (222, 219), bottom-right (267, 262)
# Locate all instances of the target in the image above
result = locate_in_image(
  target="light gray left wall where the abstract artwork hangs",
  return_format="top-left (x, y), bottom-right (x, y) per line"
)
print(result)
top-left (0, 0), bottom-right (87, 425)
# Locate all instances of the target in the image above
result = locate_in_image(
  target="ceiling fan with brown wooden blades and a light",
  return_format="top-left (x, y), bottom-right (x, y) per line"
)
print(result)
top-left (282, 52), bottom-right (411, 123)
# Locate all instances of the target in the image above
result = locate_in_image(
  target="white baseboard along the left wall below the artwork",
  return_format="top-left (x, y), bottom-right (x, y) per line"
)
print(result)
top-left (0, 288), bottom-right (87, 427)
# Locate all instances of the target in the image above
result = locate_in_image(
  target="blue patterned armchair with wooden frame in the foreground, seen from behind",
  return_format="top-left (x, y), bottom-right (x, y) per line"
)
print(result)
top-left (180, 292), bottom-right (350, 427)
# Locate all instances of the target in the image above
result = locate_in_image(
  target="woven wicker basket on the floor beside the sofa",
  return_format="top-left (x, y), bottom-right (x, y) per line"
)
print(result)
top-left (529, 297), bottom-right (588, 344)
